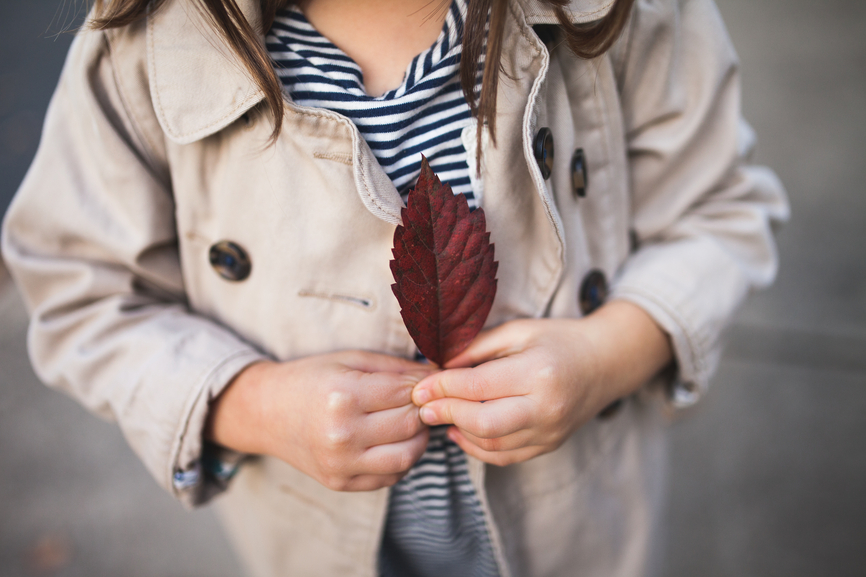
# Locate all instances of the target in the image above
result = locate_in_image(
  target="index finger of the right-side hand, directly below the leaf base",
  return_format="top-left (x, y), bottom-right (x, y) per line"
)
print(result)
top-left (412, 354), bottom-right (533, 407)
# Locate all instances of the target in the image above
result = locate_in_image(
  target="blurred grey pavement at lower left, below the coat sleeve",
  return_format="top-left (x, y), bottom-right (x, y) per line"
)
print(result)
top-left (0, 262), bottom-right (241, 577)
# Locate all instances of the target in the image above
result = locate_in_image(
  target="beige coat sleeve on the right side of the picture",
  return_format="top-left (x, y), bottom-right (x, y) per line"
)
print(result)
top-left (612, 0), bottom-right (789, 405)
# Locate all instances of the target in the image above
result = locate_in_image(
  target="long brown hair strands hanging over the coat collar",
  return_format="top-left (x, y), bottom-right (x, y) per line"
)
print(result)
top-left (91, 0), bottom-right (634, 146)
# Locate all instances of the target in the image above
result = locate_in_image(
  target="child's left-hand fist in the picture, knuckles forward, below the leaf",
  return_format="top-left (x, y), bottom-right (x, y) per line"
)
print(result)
top-left (205, 351), bottom-right (434, 491)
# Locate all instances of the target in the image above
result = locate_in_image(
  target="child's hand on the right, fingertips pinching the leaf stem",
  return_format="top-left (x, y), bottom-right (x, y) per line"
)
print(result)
top-left (412, 301), bottom-right (671, 465)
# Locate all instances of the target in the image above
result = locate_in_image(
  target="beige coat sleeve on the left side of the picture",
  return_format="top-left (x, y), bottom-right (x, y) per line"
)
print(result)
top-left (2, 27), bottom-right (263, 505)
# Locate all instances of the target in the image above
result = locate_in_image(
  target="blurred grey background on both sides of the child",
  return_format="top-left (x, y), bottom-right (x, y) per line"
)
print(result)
top-left (0, 0), bottom-right (866, 577)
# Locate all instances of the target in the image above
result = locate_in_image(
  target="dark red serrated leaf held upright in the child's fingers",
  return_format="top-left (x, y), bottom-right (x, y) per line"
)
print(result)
top-left (391, 158), bottom-right (499, 366)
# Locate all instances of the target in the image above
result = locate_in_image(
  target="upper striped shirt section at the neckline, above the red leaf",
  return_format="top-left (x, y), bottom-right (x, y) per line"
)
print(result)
top-left (266, 0), bottom-right (480, 208)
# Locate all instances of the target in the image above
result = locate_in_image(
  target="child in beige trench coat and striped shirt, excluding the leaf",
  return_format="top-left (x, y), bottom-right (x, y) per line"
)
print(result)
top-left (3, 0), bottom-right (787, 577)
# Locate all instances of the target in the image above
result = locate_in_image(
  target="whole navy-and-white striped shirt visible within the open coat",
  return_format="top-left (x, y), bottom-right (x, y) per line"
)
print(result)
top-left (267, 0), bottom-right (499, 577)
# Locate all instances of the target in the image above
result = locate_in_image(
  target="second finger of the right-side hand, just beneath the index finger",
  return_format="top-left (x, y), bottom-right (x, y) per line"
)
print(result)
top-left (419, 397), bottom-right (532, 439)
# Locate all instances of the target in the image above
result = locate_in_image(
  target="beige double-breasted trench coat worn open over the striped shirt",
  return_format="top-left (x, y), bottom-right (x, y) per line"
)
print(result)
top-left (2, 0), bottom-right (787, 577)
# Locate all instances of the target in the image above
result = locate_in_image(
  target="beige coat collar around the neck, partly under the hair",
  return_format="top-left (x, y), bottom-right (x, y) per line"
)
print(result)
top-left (147, 0), bottom-right (614, 144)
